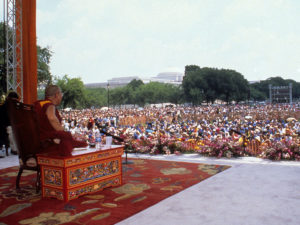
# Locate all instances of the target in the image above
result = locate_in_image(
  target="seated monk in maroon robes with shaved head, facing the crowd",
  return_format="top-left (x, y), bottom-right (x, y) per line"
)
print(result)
top-left (34, 85), bottom-right (87, 156)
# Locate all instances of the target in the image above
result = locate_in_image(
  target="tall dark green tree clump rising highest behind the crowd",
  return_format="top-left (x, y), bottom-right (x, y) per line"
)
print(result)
top-left (182, 66), bottom-right (249, 104)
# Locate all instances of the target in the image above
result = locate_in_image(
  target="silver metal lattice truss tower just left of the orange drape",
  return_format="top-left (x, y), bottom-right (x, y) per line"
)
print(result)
top-left (4, 0), bottom-right (23, 101)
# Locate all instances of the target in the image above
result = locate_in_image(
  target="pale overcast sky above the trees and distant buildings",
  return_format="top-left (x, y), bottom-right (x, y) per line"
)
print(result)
top-left (4, 0), bottom-right (300, 83)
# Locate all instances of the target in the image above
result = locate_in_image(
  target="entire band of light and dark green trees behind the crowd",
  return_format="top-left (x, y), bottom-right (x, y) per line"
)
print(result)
top-left (50, 69), bottom-right (300, 108)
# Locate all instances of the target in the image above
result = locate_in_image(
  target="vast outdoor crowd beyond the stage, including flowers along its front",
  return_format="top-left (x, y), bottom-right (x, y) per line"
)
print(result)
top-left (61, 104), bottom-right (300, 160)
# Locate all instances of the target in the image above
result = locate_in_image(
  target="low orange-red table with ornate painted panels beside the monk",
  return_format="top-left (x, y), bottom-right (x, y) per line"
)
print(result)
top-left (37, 145), bottom-right (124, 202)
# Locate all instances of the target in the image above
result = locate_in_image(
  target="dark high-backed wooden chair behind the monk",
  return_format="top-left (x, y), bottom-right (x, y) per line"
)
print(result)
top-left (7, 99), bottom-right (40, 192)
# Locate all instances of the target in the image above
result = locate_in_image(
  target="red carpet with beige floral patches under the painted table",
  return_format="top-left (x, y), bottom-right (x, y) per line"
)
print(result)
top-left (0, 159), bottom-right (229, 225)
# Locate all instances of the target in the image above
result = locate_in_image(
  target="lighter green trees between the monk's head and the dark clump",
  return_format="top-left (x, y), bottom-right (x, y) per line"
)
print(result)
top-left (49, 75), bottom-right (184, 109)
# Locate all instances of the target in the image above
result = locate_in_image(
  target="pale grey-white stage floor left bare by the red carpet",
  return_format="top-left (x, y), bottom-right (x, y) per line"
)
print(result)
top-left (0, 154), bottom-right (300, 225)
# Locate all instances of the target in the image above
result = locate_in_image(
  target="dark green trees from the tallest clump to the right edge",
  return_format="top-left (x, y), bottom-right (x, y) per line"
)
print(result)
top-left (182, 65), bottom-right (300, 105)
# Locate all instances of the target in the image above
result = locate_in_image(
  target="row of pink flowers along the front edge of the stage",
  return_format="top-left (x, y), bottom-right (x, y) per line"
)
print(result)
top-left (125, 133), bottom-right (300, 161)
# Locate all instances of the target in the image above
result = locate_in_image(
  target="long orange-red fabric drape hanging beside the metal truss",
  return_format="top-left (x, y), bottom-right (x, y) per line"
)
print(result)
top-left (16, 0), bottom-right (37, 104)
